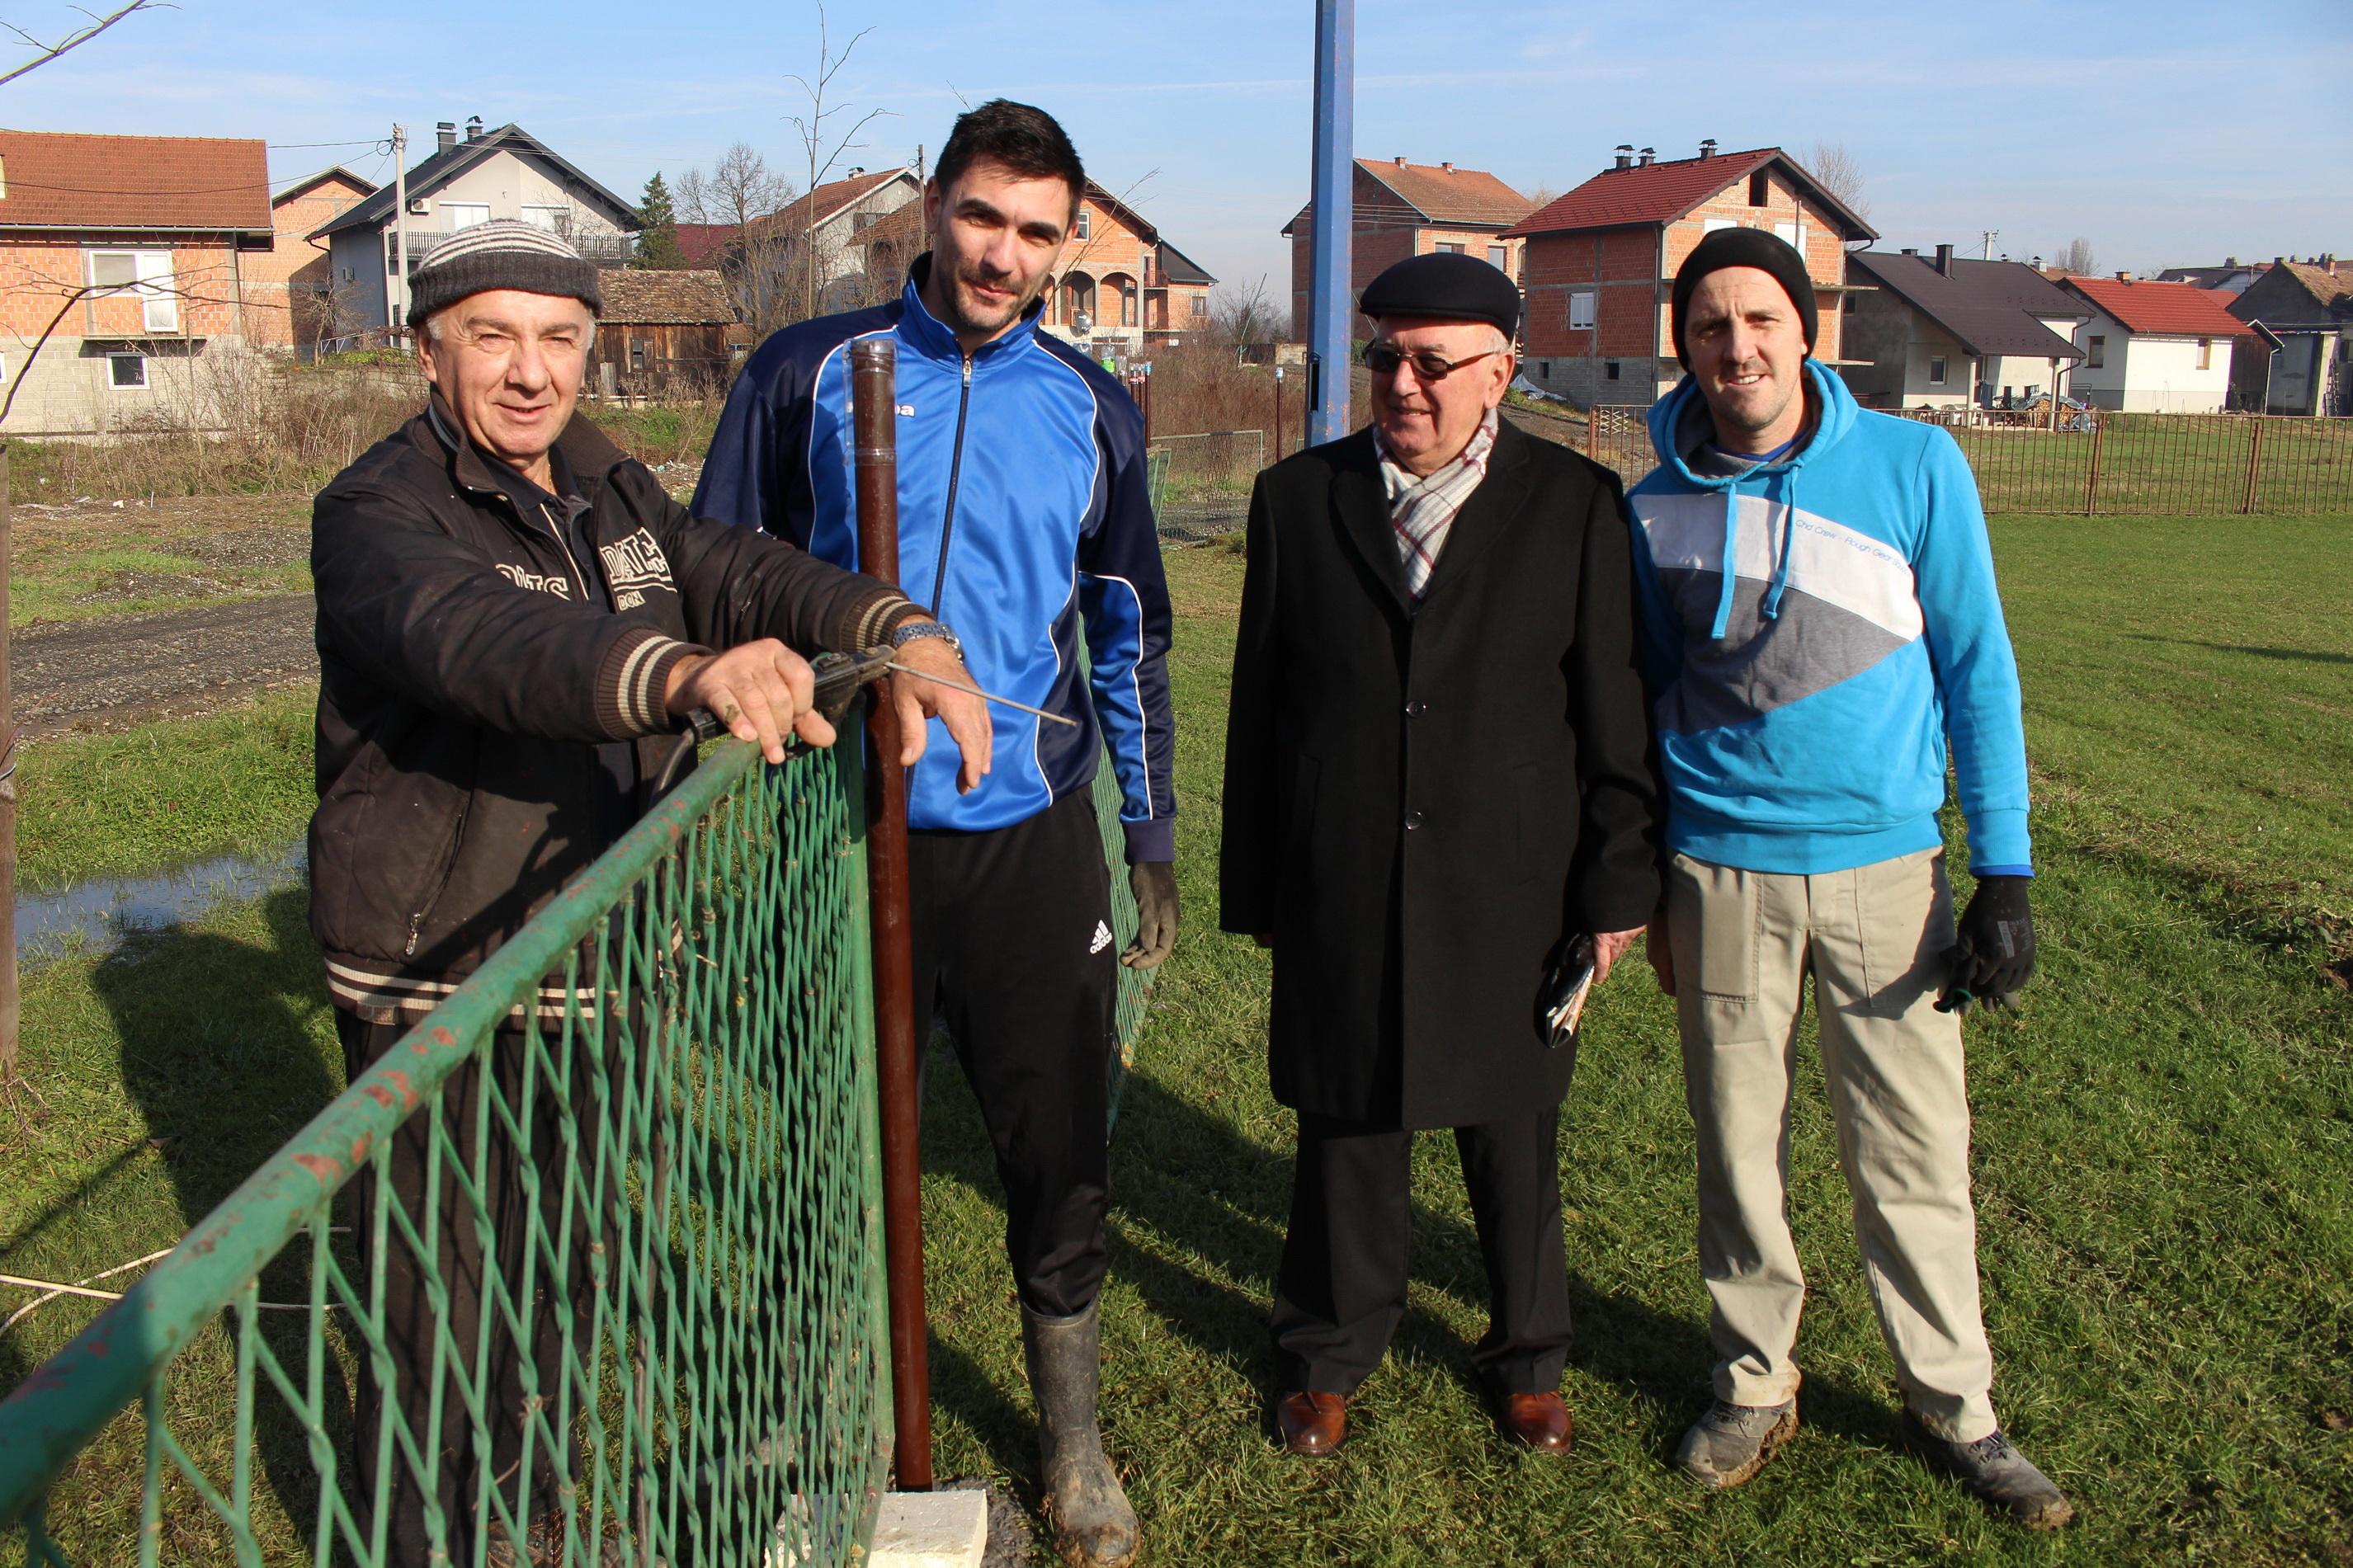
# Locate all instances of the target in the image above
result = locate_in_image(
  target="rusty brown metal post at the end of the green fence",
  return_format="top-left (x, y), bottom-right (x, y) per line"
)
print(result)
top-left (850, 338), bottom-right (931, 1493)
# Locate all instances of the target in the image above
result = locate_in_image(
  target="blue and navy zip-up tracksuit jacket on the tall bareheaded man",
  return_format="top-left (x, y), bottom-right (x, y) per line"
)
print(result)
top-left (694, 257), bottom-right (1176, 863)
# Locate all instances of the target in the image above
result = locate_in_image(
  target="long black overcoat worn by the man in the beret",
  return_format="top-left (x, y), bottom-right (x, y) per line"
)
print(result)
top-left (1219, 423), bottom-right (1662, 1128)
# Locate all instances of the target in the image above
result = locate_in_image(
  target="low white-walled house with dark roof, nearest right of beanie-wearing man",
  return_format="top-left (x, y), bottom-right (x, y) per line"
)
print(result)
top-left (1837, 244), bottom-right (2091, 409)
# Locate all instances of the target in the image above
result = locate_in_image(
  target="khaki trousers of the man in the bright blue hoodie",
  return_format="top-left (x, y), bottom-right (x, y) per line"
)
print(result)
top-left (1666, 849), bottom-right (1995, 1443)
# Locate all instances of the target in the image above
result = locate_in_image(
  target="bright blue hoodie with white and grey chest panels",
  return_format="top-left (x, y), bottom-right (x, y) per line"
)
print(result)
top-left (1629, 360), bottom-right (2033, 877)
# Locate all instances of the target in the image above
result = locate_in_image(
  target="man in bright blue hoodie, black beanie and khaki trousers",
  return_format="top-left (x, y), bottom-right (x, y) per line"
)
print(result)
top-left (1629, 228), bottom-right (2073, 1528)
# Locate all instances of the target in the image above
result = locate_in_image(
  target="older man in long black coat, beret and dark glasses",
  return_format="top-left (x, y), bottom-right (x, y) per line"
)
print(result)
top-left (1219, 254), bottom-right (1659, 1455)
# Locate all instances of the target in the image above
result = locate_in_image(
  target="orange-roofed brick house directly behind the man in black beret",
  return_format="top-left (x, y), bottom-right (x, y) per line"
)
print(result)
top-left (1282, 158), bottom-right (1535, 341)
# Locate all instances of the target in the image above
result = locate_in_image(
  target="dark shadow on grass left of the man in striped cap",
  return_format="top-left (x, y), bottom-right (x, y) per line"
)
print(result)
top-left (92, 886), bottom-right (351, 1537)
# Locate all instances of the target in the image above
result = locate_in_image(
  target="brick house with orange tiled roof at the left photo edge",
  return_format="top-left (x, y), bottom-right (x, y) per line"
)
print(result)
top-left (0, 129), bottom-right (276, 435)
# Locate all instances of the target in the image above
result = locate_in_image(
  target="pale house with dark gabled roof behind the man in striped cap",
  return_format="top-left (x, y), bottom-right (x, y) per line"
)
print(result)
top-left (310, 115), bottom-right (638, 341)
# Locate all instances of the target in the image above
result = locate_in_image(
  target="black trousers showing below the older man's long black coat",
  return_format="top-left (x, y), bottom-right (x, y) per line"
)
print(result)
top-left (1273, 1105), bottom-right (1569, 1394)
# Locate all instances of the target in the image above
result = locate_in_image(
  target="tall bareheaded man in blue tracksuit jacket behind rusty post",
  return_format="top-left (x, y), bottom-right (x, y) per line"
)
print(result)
top-left (694, 99), bottom-right (1176, 1566)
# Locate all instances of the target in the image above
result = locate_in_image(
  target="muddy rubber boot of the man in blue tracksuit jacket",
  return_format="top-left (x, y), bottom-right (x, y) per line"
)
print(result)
top-left (1021, 1307), bottom-right (1137, 1568)
